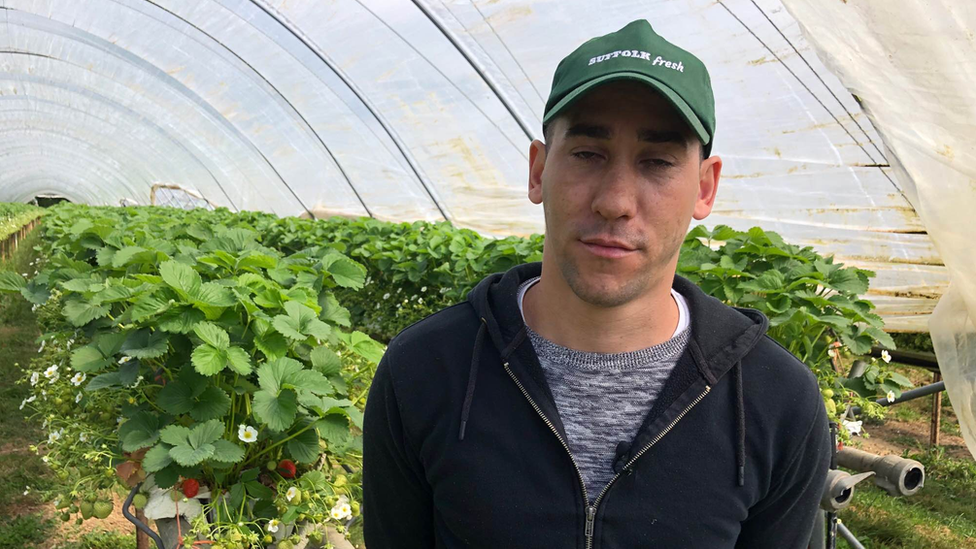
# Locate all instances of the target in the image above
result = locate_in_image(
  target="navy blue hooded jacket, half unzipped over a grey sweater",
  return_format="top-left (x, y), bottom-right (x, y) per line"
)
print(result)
top-left (363, 263), bottom-right (830, 549)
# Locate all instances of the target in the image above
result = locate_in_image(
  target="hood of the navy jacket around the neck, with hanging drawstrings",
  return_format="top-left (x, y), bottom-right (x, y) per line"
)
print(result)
top-left (458, 263), bottom-right (769, 486)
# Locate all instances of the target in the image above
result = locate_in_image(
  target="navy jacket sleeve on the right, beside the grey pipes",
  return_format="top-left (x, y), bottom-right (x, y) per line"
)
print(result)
top-left (735, 398), bottom-right (830, 549)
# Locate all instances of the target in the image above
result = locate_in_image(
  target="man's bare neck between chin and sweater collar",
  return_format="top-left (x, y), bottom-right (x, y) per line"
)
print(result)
top-left (522, 268), bottom-right (679, 353)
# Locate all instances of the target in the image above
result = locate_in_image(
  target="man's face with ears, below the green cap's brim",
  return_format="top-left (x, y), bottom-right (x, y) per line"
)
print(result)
top-left (529, 81), bottom-right (721, 307)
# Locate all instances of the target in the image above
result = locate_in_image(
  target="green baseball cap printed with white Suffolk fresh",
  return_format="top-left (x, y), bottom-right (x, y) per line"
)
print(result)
top-left (542, 19), bottom-right (715, 151)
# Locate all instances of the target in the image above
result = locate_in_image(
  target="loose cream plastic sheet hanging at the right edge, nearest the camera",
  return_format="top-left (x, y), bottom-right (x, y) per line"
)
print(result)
top-left (787, 0), bottom-right (976, 456)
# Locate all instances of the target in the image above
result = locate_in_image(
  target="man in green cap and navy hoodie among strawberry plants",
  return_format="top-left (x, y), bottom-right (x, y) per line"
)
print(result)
top-left (363, 21), bottom-right (830, 549)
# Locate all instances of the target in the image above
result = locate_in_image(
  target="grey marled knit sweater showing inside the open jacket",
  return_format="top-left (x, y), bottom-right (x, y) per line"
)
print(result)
top-left (519, 278), bottom-right (691, 496)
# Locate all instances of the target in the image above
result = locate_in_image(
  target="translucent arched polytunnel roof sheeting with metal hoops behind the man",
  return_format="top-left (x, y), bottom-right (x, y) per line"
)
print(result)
top-left (0, 0), bottom-right (948, 331)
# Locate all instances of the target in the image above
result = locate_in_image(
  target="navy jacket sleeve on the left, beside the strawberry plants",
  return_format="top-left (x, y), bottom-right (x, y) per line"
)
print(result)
top-left (363, 345), bottom-right (434, 549)
